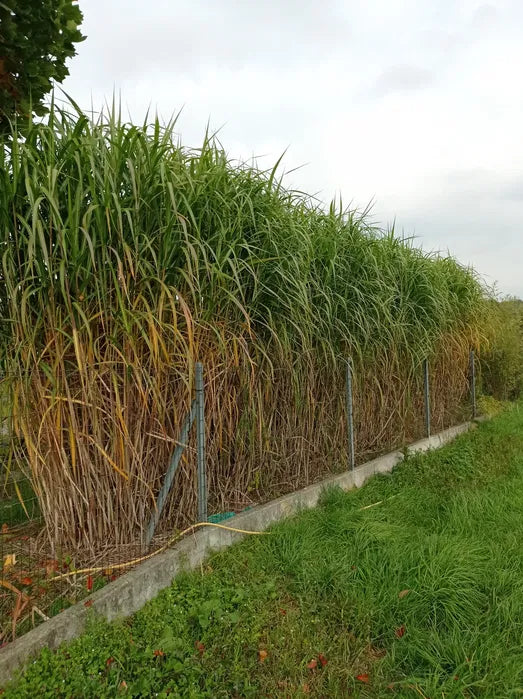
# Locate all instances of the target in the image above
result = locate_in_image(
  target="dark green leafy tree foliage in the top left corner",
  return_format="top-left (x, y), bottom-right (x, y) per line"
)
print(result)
top-left (0, 0), bottom-right (85, 133)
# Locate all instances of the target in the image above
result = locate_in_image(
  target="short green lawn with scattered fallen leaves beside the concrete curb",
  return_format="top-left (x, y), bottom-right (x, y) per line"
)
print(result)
top-left (4, 405), bottom-right (523, 699)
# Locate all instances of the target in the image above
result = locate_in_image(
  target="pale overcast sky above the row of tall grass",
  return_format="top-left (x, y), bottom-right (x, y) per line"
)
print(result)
top-left (64, 0), bottom-right (523, 297)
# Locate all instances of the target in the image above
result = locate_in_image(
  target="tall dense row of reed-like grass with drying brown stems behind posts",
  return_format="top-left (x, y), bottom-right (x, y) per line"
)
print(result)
top-left (0, 105), bottom-right (492, 549)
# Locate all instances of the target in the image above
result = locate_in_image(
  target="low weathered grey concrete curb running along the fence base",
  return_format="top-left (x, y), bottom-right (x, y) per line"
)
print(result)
top-left (0, 422), bottom-right (475, 683)
